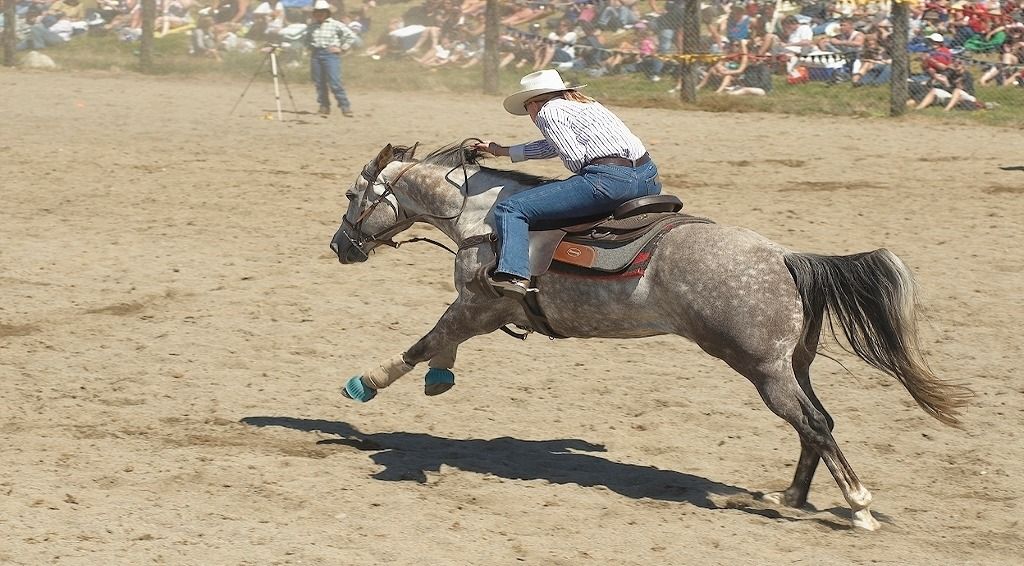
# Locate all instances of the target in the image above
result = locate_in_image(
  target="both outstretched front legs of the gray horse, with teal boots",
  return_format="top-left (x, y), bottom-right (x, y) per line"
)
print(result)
top-left (342, 296), bottom-right (511, 402)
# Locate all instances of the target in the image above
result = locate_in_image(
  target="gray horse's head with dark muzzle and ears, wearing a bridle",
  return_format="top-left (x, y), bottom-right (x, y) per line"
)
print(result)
top-left (331, 143), bottom-right (416, 263)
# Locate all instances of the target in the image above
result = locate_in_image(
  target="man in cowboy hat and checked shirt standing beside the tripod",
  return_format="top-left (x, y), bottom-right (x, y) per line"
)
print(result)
top-left (306, 0), bottom-right (358, 118)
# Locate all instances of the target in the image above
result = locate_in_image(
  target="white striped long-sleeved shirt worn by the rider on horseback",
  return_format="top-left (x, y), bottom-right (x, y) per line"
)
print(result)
top-left (509, 98), bottom-right (647, 173)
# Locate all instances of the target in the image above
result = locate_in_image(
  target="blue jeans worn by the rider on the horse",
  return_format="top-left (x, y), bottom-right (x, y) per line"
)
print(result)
top-left (495, 161), bottom-right (662, 279)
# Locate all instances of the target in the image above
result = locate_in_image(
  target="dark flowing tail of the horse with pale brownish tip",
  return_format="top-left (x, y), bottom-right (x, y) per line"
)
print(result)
top-left (785, 249), bottom-right (974, 426)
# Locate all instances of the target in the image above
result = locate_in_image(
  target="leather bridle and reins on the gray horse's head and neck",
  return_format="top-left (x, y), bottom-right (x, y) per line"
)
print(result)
top-left (336, 137), bottom-right (481, 259)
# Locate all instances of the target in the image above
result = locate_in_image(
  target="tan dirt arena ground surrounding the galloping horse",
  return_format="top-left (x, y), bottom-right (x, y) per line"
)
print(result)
top-left (0, 71), bottom-right (1024, 566)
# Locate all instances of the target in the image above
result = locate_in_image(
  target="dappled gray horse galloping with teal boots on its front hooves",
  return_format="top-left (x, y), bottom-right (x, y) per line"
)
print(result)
top-left (331, 144), bottom-right (971, 530)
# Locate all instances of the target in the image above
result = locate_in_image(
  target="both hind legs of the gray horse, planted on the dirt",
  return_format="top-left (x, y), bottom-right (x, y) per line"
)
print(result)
top-left (743, 360), bottom-right (880, 530)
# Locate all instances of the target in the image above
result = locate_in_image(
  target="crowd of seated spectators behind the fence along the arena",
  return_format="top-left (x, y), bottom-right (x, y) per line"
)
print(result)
top-left (2, 0), bottom-right (1024, 101)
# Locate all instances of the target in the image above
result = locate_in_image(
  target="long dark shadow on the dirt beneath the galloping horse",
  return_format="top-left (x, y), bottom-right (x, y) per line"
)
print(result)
top-left (242, 417), bottom-right (850, 530)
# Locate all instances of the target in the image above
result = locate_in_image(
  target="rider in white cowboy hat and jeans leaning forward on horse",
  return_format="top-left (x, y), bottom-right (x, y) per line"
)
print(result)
top-left (476, 70), bottom-right (662, 297)
